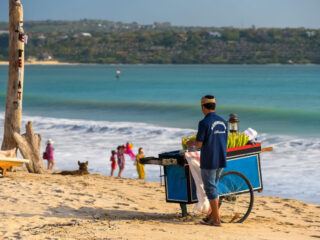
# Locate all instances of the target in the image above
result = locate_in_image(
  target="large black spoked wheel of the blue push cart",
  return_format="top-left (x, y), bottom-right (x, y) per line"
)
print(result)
top-left (218, 171), bottom-right (254, 223)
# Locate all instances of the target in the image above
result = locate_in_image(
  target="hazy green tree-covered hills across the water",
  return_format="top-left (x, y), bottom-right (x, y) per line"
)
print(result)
top-left (0, 20), bottom-right (320, 64)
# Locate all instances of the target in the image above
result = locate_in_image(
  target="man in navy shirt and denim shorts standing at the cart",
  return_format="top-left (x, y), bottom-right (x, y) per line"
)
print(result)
top-left (187, 95), bottom-right (228, 227)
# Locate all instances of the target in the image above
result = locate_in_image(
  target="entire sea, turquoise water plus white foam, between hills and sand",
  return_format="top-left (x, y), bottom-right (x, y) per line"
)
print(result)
top-left (0, 65), bottom-right (320, 204)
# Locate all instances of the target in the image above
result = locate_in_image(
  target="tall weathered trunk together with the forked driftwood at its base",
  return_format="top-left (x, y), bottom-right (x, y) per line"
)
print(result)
top-left (1, 0), bottom-right (45, 173)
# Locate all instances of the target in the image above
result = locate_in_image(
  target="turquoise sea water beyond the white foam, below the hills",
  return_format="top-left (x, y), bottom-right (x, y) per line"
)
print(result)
top-left (0, 65), bottom-right (320, 135)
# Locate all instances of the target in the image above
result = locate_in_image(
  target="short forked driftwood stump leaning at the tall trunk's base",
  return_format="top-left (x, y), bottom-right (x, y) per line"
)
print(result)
top-left (13, 122), bottom-right (45, 173)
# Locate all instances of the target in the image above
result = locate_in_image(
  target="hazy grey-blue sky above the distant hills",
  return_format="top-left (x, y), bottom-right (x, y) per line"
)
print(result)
top-left (0, 0), bottom-right (320, 29)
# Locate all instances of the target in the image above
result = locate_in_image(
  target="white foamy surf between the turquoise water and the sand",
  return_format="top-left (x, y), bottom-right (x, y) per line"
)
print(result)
top-left (0, 114), bottom-right (320, 203)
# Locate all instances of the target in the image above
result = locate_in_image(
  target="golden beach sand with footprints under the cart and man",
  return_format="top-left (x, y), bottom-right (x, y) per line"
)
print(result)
top-left (0, 170), bottom-right (320, 240)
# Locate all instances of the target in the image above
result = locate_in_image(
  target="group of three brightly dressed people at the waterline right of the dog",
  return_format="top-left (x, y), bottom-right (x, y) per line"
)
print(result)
top-left (110, 143), bottom-right (146, 179)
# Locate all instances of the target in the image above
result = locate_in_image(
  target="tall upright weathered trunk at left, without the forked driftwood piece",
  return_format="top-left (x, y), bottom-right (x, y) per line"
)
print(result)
top-left (1, 0), bottom-right (24, 150)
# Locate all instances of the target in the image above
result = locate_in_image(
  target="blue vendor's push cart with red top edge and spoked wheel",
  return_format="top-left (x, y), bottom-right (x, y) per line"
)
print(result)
top-left (140, 143), bottom-right (263, 223)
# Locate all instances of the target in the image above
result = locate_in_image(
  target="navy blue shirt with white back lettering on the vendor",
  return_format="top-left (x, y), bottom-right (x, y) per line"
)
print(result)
top-left (196, 112), bottom-right (228, 169)
